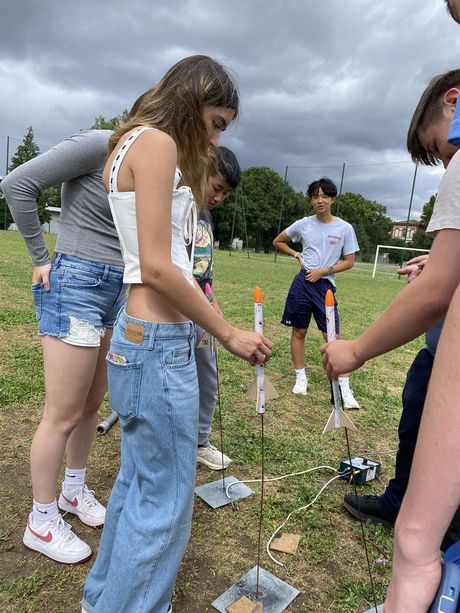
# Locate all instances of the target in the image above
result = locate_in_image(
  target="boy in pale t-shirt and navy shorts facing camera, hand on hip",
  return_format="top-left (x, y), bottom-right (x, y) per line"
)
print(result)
top-left (273, 177), bottom-right (359, 409)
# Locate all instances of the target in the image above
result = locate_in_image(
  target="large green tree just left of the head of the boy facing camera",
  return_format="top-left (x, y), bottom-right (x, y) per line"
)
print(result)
top-left (213, 166), bottom-right (309, 253)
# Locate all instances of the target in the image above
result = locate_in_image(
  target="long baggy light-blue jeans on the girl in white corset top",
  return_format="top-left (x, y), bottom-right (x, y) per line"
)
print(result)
top-left (82, 310), bottom-right (198, 613)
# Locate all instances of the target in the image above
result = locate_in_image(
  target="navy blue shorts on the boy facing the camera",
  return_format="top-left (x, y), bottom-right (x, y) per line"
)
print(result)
top-left (281, 270), bottom-right (340, 334)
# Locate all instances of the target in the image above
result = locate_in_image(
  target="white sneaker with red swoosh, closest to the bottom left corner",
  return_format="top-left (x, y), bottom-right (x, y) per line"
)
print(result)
top-left (22, 514), bottom-right (91, 564)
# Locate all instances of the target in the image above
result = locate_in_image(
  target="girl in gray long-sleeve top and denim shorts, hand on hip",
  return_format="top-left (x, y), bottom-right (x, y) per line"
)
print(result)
top-left (1, 130), bottom-right (126, 564)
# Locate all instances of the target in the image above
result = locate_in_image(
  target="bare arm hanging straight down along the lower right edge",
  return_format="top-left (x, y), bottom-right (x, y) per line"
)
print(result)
top-left (385, 280), bottom-right (460, 613)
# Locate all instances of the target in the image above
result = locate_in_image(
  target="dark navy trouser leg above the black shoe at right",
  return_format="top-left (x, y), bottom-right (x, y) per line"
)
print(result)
top-left (380, 348), bottom-right (434, 513)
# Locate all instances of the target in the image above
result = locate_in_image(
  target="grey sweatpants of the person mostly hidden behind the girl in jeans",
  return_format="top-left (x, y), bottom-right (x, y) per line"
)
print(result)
top-left (195, 325), bottom-right (217, 445)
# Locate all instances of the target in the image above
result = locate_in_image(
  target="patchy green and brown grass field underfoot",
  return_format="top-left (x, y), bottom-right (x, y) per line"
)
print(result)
top-left (0, 232), bottom-right (423, 613)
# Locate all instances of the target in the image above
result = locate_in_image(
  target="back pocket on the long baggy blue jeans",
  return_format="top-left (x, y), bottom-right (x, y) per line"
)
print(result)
top-left (107, 357), bottom-right (142, 424)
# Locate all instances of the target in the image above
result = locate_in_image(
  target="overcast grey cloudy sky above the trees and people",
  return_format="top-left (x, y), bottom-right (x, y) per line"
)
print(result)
top-left (0, 0), bottom-right (460, 219)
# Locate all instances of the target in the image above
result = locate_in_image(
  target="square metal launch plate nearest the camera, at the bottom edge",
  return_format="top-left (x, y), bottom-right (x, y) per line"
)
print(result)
top-left (212, 568), bottom-right (300, 613)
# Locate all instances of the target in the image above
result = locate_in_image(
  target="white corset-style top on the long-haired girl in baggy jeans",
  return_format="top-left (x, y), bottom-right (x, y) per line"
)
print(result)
top-left (108, 127), bottom-right (197, 285)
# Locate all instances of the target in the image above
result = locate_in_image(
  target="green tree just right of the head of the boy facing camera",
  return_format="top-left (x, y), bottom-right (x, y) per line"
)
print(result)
top-left (332, 192), bottom-right (393, 261)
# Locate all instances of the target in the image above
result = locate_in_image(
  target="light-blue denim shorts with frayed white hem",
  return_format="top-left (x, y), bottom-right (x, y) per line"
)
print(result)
top-left (32, 253), bottom-right (127, 347)
